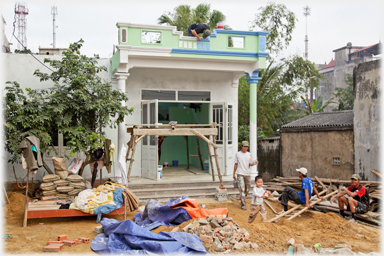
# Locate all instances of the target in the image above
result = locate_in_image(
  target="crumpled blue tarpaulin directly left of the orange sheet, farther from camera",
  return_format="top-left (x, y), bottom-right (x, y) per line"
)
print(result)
top-left (133, 196), bottom-right (192, 230)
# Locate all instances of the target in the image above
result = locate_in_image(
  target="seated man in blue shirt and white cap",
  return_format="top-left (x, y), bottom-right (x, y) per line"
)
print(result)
top-left (279, 167), bottom-right (324, 213)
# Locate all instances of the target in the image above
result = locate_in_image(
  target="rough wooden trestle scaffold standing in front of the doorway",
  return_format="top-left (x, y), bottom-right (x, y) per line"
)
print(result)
top-left (125, 123), bottom-right (224, 189)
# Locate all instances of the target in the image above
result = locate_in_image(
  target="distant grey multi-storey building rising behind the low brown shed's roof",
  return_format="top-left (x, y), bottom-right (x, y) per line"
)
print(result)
top-left (315, 43), bottom-right (381, 111)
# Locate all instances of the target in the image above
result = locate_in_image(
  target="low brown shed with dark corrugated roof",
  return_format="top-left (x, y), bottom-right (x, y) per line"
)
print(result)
top-left (280, 110), bottom-right (354, 180)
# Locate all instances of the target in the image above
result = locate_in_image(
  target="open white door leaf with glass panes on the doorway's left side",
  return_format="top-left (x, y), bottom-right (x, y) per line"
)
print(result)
top-left (141, 100), bottom-right (158, 180)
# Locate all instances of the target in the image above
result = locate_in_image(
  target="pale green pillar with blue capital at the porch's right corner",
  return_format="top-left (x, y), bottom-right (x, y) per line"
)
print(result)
top-left (245, 70), bottom-right (261, 181)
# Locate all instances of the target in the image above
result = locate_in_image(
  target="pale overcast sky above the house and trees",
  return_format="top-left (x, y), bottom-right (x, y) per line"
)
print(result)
top-left (1, 0), bottom-right (383, 64)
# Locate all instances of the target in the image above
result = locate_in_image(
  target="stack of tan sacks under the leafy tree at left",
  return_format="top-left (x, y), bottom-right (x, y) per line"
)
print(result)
top-left (40, 174), bottom-right (86, 200)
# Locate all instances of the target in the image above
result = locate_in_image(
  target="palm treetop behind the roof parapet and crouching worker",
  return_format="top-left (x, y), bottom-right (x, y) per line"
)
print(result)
top-left (157, 4), bottom-right (226, 36)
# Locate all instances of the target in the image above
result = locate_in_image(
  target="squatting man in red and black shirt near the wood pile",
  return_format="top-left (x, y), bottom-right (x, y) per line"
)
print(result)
top-left (331, 174), bottom-right (369, 222)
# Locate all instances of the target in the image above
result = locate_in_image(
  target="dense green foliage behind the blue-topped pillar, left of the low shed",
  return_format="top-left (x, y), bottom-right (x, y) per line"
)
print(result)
top-left (238, 56), bottom-right (322, 137)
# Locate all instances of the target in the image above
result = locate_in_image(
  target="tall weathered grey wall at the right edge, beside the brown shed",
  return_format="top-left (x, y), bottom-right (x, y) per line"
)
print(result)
top-left (353, 60), bottom-right (382, 180)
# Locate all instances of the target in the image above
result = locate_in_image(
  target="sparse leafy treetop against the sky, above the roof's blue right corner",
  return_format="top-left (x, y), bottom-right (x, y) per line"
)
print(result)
top-left (251, 3), bottom-right (297, 58)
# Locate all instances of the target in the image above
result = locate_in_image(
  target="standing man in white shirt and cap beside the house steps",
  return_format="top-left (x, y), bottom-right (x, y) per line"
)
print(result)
top-left (233, 141), bottom-right (258, 210)
